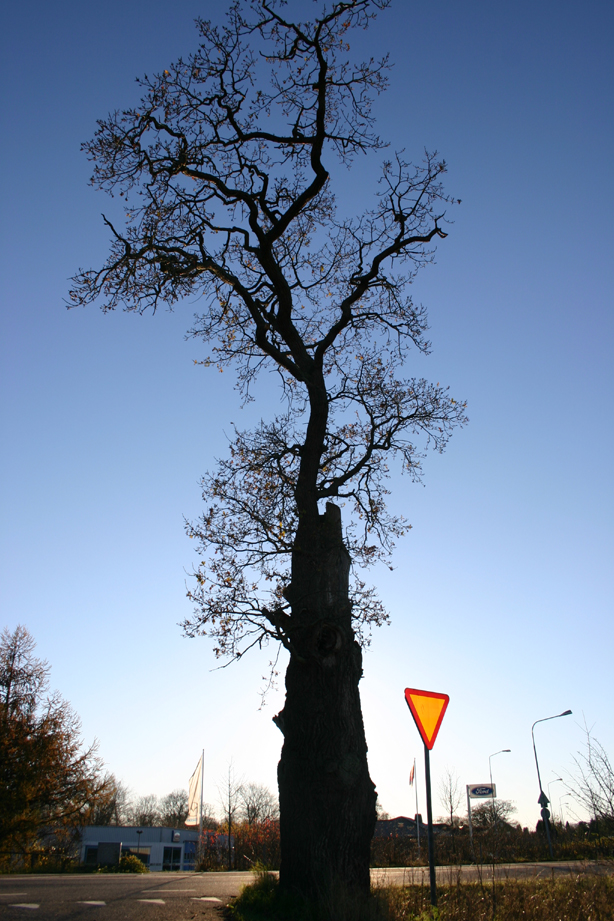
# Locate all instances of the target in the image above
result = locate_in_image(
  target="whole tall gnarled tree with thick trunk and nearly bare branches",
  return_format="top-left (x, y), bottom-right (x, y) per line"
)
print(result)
top-left (71, 0), bottom-right (465, 897)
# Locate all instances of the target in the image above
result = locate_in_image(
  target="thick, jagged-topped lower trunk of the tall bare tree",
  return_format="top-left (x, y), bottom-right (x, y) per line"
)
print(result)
top-left (275, 504), bottom-right (376, 902)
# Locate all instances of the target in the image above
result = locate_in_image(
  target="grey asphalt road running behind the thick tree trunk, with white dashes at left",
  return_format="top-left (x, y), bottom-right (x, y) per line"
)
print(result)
top-left (0, 861), bottom-right (612, 921)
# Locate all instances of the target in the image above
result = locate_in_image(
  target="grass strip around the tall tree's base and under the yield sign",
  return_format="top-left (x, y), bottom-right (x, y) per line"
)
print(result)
top-left (228, 873), bottom-right (614, 921)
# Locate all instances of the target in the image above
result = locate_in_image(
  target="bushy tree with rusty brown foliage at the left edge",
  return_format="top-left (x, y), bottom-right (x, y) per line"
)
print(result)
top-left (0, 626), bottom-right (110, 863)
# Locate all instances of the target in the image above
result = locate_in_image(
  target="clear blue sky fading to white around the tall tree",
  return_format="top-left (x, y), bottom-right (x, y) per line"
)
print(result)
top-left (0, 0), bottom-right (614, 824)
